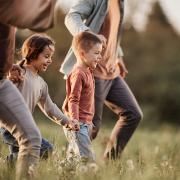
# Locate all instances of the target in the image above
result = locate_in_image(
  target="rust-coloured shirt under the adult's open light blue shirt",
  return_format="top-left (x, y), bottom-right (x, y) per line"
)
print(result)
top-left (94, 0), bottom-right (120, 79)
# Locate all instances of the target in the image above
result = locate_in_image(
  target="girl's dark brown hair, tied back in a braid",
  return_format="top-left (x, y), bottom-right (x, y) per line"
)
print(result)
top-left (19, 34), bottom-right (55, 66)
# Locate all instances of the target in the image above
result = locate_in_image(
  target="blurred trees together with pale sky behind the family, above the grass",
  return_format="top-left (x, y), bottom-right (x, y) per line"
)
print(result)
top-left (17, 0), bottom-right (180, 126)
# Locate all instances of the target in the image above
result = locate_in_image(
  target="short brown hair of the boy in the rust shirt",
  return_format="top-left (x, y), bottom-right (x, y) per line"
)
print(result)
top-left (72, 31), bottom-right (102, 53)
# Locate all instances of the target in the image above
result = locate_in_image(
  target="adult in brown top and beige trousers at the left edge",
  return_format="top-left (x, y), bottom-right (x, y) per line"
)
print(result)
top-left (0, 0), bottom-right (56, 179)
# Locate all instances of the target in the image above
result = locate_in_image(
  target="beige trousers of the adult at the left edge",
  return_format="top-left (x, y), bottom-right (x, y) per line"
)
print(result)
top-left (0, 80), bottom-right (41, 179)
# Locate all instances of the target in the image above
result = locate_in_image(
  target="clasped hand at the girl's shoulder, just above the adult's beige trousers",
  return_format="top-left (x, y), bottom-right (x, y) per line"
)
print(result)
top-left (8, 64), bottom-right (24, 84)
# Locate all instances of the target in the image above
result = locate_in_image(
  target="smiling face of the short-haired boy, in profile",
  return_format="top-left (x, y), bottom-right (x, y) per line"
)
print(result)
top-left (81, 43), bottom-right (102, 69)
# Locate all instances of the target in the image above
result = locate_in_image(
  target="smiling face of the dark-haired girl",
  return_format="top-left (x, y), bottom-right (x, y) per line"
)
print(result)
top-left (30, 45), bottom-right (55, 72)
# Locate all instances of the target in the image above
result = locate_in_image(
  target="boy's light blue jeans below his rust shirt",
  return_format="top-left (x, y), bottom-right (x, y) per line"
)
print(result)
top-left (64, 123), bottom-right (95, 161)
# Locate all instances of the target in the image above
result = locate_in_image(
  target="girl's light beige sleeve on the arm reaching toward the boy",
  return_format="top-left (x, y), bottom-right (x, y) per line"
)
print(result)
top-left (38, 82), bottom-right (69, 125)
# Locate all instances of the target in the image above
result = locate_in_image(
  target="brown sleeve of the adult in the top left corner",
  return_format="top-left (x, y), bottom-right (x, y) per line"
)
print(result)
top-left (0, 0), bottom-right (56, 31)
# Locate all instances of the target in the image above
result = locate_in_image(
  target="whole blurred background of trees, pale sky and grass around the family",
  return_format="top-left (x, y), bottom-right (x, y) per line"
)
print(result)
top-left (0, 0), bottom-right (180, 180)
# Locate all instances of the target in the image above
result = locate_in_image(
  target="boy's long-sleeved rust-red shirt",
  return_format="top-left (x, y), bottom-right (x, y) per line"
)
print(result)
top-left (63, 65), bottom-right (94, 124)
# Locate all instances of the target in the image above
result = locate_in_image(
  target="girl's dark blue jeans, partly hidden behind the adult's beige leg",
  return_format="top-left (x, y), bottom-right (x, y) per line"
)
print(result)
top-left (0, 128), bottom-right (53, 159)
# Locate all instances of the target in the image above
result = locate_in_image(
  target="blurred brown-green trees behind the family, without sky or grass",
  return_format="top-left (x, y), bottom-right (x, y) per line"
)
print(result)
top-left (17, 3), bottom-right (180, 123)
